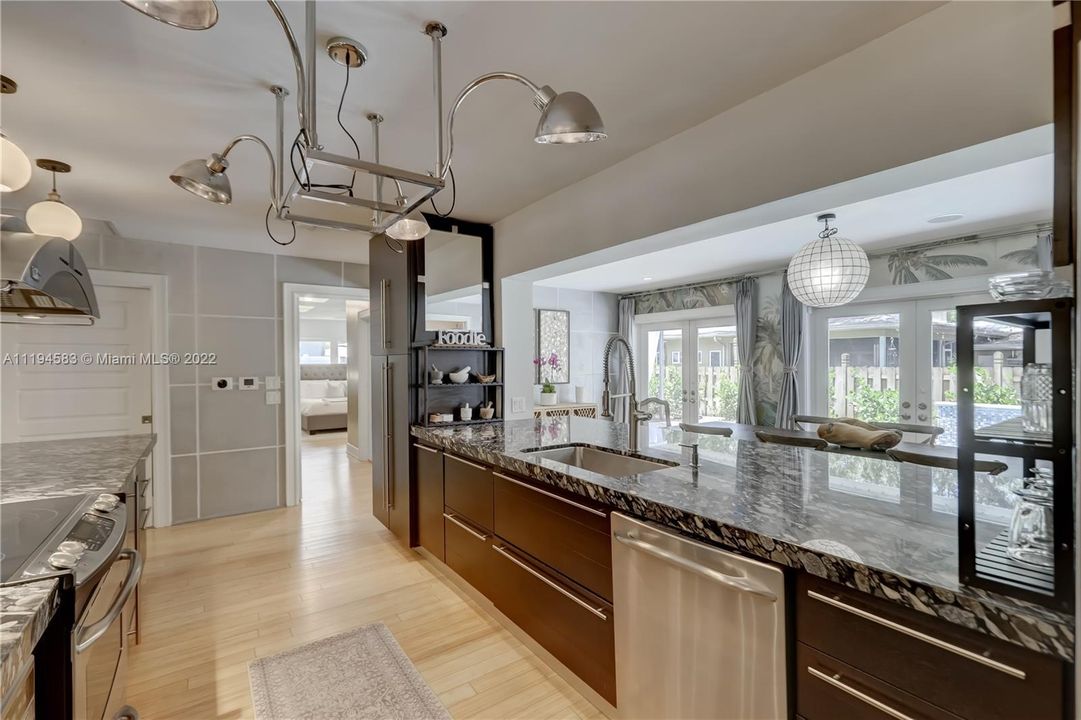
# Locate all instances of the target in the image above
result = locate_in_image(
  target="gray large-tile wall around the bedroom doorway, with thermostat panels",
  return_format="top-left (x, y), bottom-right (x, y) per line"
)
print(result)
top-left (76, 232), bottom-right (369, 522)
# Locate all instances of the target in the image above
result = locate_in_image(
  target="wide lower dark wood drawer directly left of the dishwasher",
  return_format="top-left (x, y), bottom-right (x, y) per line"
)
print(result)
top-left (490, 537), bottom-right (615, 704)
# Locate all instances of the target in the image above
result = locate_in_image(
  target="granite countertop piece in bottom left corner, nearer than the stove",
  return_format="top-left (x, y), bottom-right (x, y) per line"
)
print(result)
top-left (0, 578), bottom-right (58, 696)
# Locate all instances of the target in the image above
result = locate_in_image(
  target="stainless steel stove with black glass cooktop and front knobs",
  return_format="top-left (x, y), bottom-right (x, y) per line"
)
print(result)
top-left (0, 495), bottom-right (143, 720)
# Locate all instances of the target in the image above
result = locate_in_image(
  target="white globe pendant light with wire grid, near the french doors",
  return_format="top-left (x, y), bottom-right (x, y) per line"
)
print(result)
top-left (788, 213), bottom-right (870, 307)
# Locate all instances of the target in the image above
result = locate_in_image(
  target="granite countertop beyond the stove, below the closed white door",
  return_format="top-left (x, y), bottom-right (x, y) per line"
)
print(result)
top-left (0, 434), bottom-right (157, 503)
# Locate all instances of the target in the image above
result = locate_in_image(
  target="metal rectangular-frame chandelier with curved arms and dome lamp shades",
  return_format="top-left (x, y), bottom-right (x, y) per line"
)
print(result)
top-left (122, 0), bottom-right (606, 244)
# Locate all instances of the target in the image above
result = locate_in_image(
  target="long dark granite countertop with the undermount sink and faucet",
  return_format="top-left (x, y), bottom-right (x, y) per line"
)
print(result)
top-left (412, 417), bottom-right (1075, 662)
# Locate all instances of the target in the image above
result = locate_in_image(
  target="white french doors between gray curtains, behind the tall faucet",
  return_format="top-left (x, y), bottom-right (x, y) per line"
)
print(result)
top-left (635, 315), bottom-right (739, 425)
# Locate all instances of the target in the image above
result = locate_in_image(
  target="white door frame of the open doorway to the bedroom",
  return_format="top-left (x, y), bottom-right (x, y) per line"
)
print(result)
top-left (281, 282), bottom-right (371, 506)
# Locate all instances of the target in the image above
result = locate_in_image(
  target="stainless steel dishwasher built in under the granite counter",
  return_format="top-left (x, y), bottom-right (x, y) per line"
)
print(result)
top-left (612, 512), bottom-right (787, 720)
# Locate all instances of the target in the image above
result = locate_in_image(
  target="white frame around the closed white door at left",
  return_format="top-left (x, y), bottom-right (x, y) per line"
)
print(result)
top-left (90, 269), bottom-right (173, 528)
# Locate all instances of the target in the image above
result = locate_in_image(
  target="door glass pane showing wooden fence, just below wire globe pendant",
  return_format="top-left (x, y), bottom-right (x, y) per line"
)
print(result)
top-left (827, 314), bottom-right (911, 423)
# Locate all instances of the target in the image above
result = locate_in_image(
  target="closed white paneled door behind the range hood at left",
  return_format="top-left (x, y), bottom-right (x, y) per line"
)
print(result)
top-left (0, 286), bottom-right (151, 442)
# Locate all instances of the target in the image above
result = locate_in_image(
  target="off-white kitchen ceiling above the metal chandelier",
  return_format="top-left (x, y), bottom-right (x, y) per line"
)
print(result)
top-left (0, 1), bottom-right (939, 261)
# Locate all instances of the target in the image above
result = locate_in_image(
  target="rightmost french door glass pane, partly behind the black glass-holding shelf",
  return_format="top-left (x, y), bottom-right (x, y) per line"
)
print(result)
top-left (931, 310), bottom-right (1024, 446)
